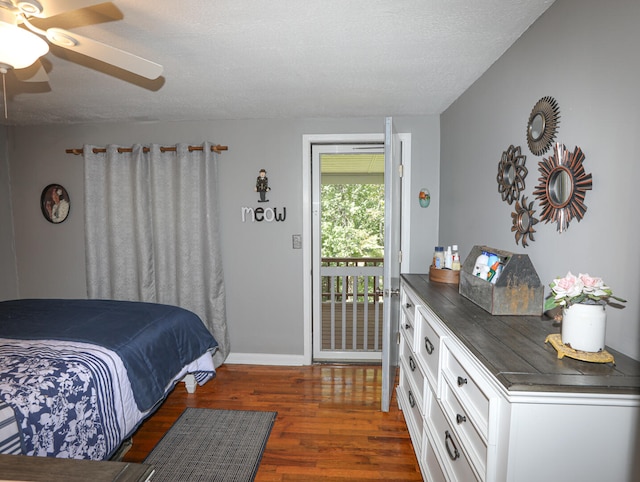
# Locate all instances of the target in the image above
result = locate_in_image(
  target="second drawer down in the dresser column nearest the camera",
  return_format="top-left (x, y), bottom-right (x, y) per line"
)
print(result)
top-left (440, 374), bottom-right (487, 474)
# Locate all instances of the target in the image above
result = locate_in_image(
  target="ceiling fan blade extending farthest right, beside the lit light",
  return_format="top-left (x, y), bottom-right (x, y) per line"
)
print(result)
top-left (47, 28), bottom-right (163, 80)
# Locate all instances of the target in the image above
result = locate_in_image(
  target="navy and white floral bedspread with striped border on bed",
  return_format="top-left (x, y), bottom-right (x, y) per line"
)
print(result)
top-left (0, 338), bottom-right (130, 460)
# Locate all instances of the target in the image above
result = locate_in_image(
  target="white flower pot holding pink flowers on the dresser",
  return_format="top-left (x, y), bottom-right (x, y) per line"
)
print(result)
top-left (562, 304), bottom-right (607, 352)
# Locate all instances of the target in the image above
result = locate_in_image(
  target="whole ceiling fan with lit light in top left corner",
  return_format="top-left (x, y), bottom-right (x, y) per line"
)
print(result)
top-left (0, 0), bottom-right (162, 117)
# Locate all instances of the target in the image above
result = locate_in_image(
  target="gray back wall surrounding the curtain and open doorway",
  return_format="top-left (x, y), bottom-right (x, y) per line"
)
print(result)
top-left (2, 116), bottom-right (440, 355)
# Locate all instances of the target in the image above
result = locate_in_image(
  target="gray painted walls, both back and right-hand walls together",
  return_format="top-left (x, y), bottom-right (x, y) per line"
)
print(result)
top-left (5, 0), bottom-right (640, 359)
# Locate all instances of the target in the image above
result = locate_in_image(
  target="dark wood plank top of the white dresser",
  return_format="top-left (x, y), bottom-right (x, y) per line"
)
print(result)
top-left (402, 274), bottom-right (640, 395)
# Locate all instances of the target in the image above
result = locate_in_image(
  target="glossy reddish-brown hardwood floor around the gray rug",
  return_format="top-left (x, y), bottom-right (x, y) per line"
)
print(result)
top-left (124, 365), bottom-right (422, 482)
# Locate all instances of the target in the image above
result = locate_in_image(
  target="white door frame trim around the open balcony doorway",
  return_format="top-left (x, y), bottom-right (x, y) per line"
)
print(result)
top-left (302, 132), bottom-right (411, 365)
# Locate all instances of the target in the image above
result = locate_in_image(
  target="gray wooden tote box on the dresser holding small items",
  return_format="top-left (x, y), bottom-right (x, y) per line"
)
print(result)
top-left (458, 246), bottom-right (544, 316)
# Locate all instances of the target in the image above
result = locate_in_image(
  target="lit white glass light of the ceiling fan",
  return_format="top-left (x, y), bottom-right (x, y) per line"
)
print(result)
top-left (0, 21), bottom-right (49, 69)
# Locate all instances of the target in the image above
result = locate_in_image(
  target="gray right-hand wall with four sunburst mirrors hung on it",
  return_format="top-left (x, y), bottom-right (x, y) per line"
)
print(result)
top-left (440, 0), bottom-right (640, 359)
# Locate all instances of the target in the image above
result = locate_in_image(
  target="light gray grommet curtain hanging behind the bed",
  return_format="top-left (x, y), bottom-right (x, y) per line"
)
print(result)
top-left (84, 143), bottom-right (229, 366)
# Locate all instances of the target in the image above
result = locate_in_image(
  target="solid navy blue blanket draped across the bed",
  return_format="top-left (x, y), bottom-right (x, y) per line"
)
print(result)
top-left (0, 299), bottom-right (217, 411)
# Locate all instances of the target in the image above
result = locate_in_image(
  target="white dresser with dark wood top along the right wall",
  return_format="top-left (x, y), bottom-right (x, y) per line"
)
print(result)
top-left (396, 275), bottom-right (640, 482)
